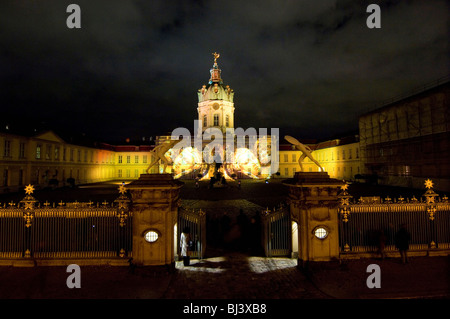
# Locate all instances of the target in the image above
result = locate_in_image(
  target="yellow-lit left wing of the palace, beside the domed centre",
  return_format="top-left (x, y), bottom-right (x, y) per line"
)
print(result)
top-left (0, 131), bottom-right (156, 193)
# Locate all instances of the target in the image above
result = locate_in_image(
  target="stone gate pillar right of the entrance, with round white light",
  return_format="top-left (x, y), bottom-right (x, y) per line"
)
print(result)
top-left (283, 172), bottom-right (344, 266)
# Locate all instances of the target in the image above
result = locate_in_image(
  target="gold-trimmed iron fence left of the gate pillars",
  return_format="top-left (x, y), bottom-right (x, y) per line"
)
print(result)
top-left (0, 185), bottom-right (132, 258)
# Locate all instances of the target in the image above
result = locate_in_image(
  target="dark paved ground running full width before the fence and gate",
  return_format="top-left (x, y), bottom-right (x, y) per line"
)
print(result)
top-left (0, 252), bottom-right (450, 300)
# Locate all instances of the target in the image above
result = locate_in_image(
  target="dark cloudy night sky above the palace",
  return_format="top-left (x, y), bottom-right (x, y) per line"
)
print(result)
top-left (0, 0), bottom-right (450, 143)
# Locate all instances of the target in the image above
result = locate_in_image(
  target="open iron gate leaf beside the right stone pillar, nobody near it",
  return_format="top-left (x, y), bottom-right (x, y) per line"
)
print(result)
top-left (262, 207), bottom-right (292, 257)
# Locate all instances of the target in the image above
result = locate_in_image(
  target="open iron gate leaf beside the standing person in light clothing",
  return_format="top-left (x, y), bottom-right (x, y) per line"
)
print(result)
top-left (179, 207), bottom-right (206, 259)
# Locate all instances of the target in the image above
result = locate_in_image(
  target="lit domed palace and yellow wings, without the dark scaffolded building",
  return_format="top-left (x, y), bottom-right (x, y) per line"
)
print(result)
top-left (0, 54), bottom-right (359, 192)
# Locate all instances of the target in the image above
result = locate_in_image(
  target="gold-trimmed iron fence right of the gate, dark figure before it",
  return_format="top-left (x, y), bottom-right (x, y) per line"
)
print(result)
top-left (339, 180), bottom-right (450, 253)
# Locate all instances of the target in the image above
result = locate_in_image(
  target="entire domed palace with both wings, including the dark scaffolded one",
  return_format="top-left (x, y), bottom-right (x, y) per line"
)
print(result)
top-left (0, 55), bottom-right (450, 192)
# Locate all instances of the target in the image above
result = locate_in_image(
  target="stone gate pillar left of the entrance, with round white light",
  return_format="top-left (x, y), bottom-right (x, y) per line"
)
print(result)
top-left (127, 174), bottom-right (184, 266)
